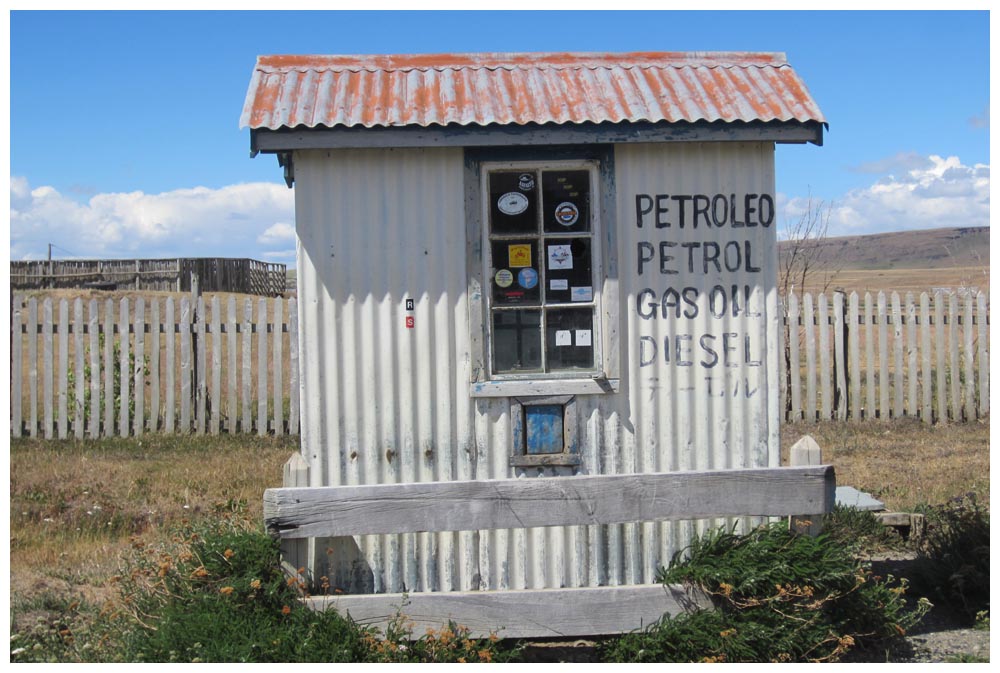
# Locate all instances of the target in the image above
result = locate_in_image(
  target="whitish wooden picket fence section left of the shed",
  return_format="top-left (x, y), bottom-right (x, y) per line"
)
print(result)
top-left (11, 296), bottom-right (299, 438)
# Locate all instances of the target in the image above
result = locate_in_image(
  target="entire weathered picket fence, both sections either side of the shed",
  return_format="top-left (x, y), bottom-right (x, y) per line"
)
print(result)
top-left (11, 292), bottom-right (989, 438)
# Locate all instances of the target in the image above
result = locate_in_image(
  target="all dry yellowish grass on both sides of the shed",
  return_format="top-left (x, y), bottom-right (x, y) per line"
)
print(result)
top-left (10, 419), bottom-right (989, 660)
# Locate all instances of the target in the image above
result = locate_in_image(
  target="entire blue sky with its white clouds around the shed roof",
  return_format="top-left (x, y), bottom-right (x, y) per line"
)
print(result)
top-left (9, 4), bottom-right (990, 264)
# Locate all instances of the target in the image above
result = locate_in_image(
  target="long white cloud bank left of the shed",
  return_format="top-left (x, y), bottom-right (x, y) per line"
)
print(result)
top-left (10, 176), bottom-right (295, 259)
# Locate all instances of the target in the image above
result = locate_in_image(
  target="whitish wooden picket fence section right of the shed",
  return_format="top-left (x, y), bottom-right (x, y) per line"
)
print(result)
top-left (781, 291), bottom-right (990, 423)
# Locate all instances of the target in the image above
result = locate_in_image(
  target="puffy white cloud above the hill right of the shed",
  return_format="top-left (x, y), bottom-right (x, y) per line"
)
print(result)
top-left (783, 154), bottom-right (990, 236)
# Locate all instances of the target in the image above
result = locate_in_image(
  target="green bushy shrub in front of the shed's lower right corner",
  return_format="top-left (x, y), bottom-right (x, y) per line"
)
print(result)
top-left (602, 524), bottom-right (930, 662)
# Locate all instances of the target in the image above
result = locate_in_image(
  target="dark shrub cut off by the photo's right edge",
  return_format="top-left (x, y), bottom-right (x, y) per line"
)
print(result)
top-left (913, 493), bottom-right (990, 625)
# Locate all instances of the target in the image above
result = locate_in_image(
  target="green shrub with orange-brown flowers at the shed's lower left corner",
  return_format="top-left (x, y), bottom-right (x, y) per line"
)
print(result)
top-left (107, 522), bottom-right (514, 663)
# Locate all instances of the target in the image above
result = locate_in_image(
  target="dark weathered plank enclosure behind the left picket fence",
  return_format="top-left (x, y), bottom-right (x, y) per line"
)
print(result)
top-left (10, 257), bottom-right (287, 297)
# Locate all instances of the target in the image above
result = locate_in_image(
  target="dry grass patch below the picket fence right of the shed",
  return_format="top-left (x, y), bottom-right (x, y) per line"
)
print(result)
top-left (781, 419), bottom-right (990, 511)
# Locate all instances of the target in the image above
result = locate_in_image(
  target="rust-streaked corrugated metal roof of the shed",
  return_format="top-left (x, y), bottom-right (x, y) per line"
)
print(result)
top-left (240, 52), bottom-right (825, 129)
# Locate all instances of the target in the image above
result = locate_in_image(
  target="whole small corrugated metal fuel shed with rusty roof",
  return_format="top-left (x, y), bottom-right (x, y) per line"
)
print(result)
top-left (241, 52), bottom-right (826, 620)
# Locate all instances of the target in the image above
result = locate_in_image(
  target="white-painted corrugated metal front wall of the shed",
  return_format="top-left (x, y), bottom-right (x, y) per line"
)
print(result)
top-left (295, 143), bottom-right (778, 591)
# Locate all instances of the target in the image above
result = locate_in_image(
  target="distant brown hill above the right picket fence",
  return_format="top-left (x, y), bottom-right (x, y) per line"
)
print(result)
top-left (778, 227), bottom-right (990, 270)
